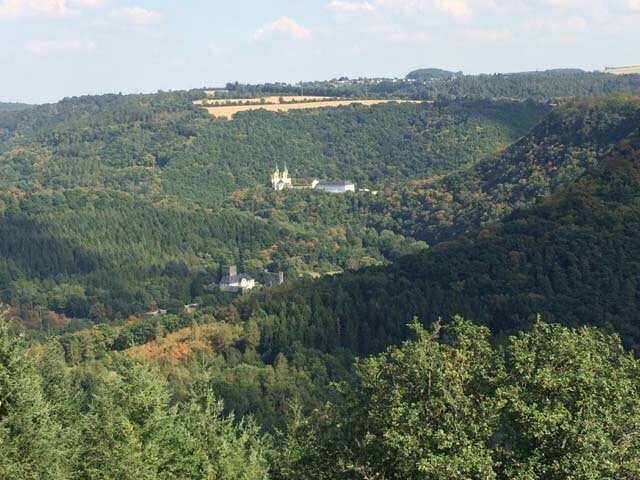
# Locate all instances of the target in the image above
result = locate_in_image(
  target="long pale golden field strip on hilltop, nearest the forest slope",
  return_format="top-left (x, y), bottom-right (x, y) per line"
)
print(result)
top-left (200, 97), bottom-right (422, 119)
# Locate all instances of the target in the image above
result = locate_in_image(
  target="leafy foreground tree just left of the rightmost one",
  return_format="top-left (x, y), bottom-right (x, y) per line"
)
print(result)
top-left (341, 319), bottom-right (496, 479)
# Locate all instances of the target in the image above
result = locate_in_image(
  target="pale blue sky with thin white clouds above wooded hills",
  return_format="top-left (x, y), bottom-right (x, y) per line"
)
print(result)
top-left (0, 0), bottom-right (640, 103)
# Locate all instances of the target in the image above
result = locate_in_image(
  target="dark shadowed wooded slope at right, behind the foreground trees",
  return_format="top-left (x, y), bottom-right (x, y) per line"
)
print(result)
top-left (238, 129), bottom-right (640, 354)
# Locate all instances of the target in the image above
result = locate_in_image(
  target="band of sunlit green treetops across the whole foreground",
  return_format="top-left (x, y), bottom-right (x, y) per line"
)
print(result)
top-left (5, 312), bottom-right (640, 480)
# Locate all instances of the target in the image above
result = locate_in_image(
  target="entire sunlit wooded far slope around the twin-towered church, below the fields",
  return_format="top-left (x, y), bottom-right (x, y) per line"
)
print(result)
top-left (0, 91), bottom-right (549, 325)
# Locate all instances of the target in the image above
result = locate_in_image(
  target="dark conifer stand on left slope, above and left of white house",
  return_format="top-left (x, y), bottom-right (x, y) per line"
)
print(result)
top-left (0, 190), bottom-right (281, 320)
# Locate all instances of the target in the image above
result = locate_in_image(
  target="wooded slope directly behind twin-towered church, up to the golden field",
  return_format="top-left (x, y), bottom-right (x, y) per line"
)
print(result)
top-left (162, 101), bottom-right (548, 203)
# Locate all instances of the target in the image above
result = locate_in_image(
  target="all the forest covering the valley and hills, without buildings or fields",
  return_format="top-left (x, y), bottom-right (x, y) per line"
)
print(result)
top-left (0, 69), bottom-right (640, 480)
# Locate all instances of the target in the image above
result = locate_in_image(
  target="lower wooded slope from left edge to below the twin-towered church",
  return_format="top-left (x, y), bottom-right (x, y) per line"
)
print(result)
top-left (0, 189), bottom-right (436, 318)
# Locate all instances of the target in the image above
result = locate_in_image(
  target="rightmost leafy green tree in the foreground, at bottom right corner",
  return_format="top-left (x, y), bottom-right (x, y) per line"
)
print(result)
top-left (496, 324), bottom-right (640, 479)
